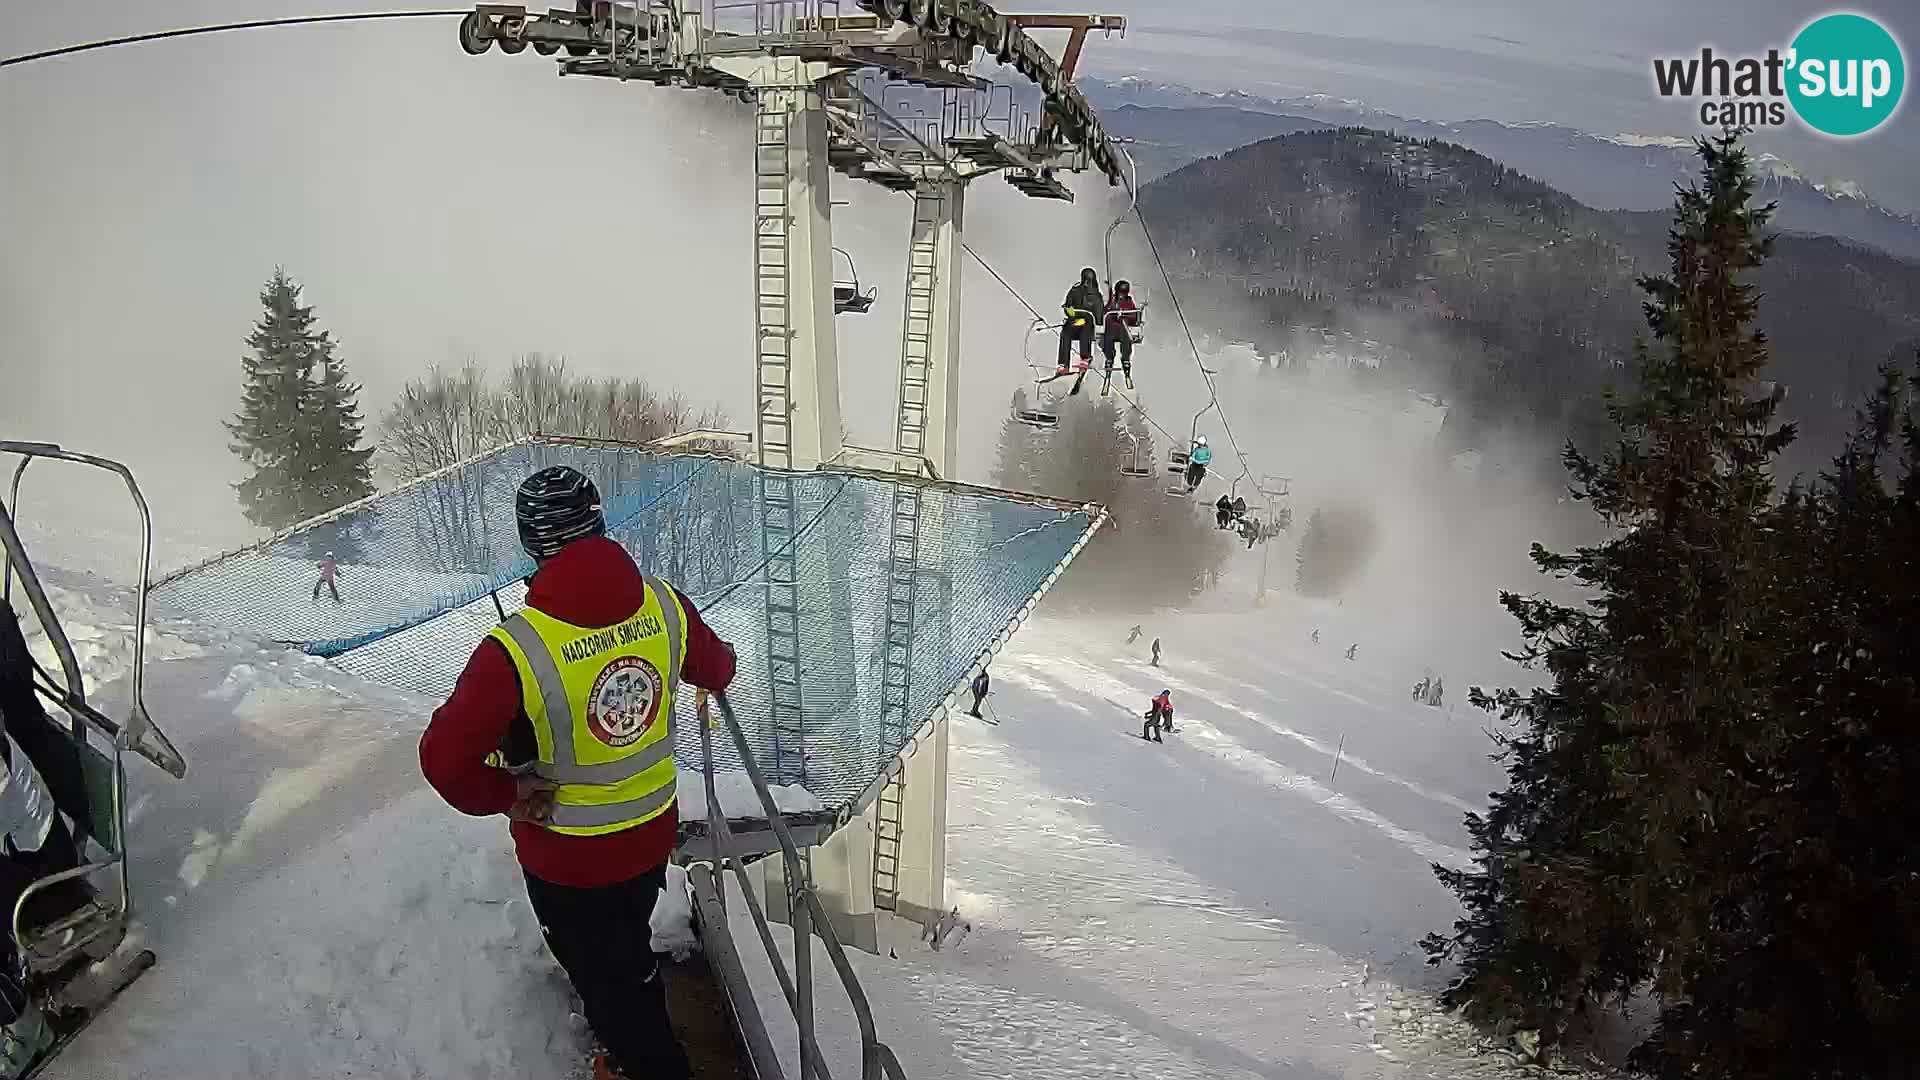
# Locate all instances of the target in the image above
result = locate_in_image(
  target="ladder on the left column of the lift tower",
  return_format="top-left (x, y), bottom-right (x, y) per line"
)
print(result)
top-left (753, 94), bottom-right (806, 784)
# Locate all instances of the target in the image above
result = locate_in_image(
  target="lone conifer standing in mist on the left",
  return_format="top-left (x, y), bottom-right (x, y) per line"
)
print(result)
top-left (227, 269), bottom-right (372, 528)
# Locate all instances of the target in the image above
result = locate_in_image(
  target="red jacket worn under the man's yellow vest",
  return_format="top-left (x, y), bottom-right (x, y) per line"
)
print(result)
top-left (420, 536), bottom-right (733, 888)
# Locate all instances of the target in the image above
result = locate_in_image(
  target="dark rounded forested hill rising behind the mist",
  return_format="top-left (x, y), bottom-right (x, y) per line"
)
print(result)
top-left (1140, 129), bottom-right (1920, 469)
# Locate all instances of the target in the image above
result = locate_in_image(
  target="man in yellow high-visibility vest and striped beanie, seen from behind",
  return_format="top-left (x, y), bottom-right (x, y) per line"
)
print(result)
top-left (420, 465), bottom-right (733, 1080)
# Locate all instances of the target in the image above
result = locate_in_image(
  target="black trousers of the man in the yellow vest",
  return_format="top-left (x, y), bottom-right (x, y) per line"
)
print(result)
top-left (526, 867), bottom-right (687, 1080)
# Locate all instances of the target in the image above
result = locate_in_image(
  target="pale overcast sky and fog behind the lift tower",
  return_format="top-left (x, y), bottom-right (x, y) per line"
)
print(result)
top-left (0, 0), bottom-right (1920, 542)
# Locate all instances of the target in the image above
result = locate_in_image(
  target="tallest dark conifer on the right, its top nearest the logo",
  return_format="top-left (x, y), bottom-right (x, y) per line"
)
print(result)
top-left (1425, 133), bottom-right (1793, 1045)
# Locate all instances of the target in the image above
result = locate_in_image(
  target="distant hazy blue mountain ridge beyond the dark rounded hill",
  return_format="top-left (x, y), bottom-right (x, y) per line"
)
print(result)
top-left (1081, 77), bottom-right (1920, 259)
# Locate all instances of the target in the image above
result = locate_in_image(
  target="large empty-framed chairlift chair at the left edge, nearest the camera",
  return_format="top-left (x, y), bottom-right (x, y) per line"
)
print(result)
top-left (0, 440), bottom-right (186, 1045)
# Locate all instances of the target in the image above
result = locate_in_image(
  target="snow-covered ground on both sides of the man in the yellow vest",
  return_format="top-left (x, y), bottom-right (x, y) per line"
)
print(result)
top-left (22, 549), bottom-right (1597, 1080)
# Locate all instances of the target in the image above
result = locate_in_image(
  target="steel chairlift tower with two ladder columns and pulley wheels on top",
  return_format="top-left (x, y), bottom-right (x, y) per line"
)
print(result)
top-left (461, 0), bottom-right (1127, 949)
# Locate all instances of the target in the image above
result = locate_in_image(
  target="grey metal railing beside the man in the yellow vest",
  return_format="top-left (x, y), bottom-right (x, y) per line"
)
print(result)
top-left (697, 694), bottom-right (906, 1080)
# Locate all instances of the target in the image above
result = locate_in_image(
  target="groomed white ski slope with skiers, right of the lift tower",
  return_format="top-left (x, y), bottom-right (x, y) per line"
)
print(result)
top-left (721, 615), bottom-right (1574, 1080)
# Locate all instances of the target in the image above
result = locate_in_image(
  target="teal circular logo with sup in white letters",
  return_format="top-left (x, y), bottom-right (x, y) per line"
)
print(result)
top-left (1788, 13), bottom-right (1907, 138)
